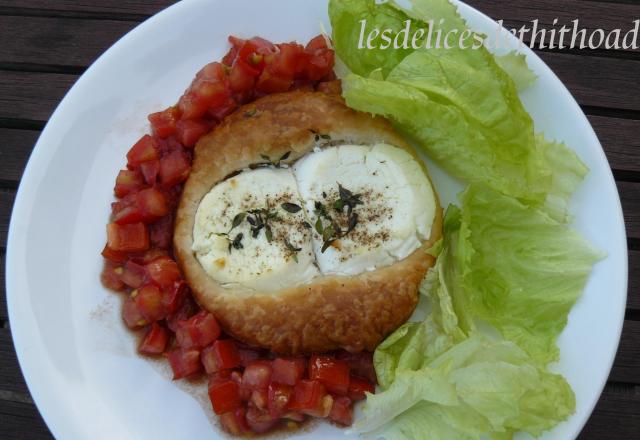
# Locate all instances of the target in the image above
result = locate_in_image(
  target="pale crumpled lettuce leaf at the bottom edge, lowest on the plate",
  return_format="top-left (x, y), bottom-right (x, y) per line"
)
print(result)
top-left (352, 319), bottom-right (575, 440)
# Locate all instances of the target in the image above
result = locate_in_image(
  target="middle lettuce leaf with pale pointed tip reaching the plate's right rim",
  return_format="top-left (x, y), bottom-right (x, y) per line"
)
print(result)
top-left (457, 185), bottom-right (603, 365)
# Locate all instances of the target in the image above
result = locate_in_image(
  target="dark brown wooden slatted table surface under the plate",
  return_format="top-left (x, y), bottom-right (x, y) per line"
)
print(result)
top-left (0, 0), bottom-right (640, 440)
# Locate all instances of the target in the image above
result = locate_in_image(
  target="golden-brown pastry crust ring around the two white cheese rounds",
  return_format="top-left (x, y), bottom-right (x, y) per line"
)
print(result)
top-left (174, 92), bottom-right (442, 354)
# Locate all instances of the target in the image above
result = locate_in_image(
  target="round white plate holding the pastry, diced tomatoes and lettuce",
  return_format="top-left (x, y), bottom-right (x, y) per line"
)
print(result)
top-left (7, 0), bottom-right (627, 439)
